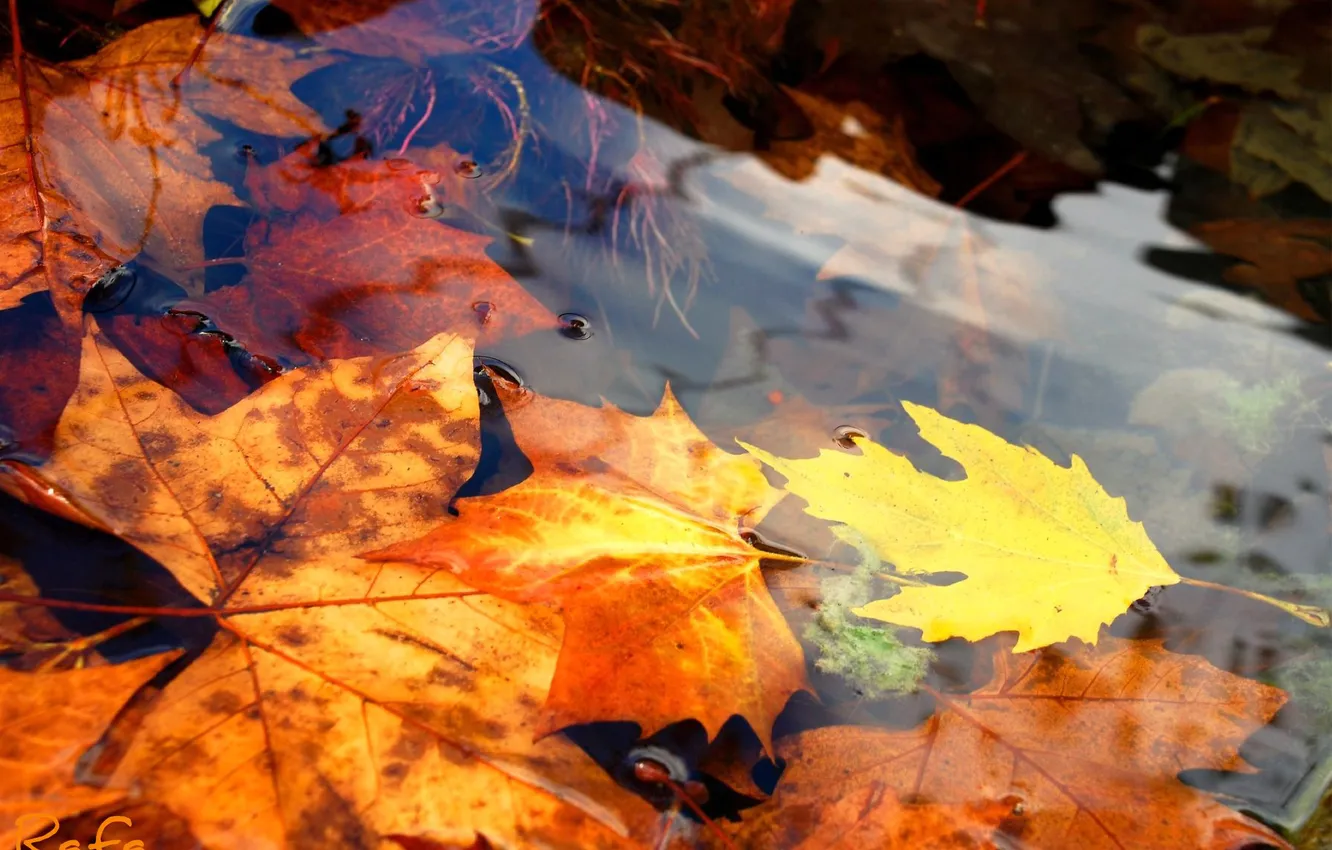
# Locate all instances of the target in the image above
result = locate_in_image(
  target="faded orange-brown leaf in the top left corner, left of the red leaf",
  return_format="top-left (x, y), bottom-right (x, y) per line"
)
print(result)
top-left (0, 19), bottom-right (326, 321)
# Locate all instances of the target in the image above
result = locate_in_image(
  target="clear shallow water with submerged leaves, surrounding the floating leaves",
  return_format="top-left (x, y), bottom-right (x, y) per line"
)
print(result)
top-left (0, 0), bottom-right (1332, 846)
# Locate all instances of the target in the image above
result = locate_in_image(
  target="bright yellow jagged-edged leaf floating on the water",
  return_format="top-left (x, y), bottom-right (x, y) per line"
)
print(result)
top-left (741, 402), bottom-right (1180, 651)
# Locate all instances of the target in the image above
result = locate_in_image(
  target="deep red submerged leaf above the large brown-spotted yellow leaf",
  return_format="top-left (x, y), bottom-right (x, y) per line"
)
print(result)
top-left (182, 147), bottom-right (557, 364)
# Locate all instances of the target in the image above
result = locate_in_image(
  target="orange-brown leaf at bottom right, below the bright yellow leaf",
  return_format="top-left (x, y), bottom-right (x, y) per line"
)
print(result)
top-left (735, 638), bottom-right (1288, 850)
